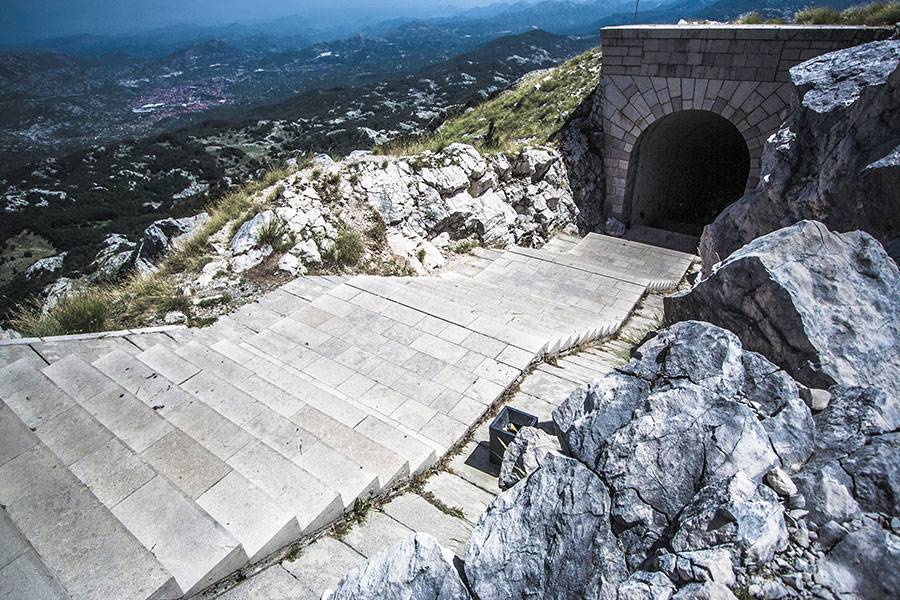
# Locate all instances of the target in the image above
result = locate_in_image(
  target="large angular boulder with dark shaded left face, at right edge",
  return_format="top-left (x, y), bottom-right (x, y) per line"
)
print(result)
top-left (665, 221), bottom-right (900, 394)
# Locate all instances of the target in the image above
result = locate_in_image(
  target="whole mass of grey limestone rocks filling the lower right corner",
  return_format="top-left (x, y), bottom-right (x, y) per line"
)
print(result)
top-left (326, 321), bottom-right (900, 600)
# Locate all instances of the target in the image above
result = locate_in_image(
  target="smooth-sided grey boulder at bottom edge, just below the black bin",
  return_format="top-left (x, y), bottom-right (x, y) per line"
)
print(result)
top-left (465, 453), bottom-right (627, 600)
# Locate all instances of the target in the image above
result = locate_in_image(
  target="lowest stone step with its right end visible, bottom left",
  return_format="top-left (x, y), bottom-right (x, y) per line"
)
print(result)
top-left (0, 386), bottom-right (184, 600)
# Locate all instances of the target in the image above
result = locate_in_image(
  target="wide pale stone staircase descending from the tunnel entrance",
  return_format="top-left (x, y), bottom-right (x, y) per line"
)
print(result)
top-left (0, 235), bottom-right (693, 599)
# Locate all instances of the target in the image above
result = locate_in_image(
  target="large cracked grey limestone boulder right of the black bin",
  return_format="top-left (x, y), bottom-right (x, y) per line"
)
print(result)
top-left (554, 321), bottom-right (815, 567)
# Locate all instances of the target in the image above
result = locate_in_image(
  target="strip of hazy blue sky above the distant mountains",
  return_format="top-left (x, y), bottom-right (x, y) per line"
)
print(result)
top-left (0, 0), bottom-right (496, 41)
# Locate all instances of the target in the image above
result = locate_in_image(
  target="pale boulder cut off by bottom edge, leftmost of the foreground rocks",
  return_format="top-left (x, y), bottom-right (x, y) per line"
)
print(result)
top-left (322, 533), bottom-right (470, 600)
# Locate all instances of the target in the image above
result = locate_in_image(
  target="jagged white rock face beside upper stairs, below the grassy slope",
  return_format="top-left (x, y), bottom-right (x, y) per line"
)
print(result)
top-left (349, 144), bottom-right (578, 254)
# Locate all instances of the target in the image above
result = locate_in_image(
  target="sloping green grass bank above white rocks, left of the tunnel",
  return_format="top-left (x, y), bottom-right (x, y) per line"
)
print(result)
top-left (375, 48), bottom-right (600, 156)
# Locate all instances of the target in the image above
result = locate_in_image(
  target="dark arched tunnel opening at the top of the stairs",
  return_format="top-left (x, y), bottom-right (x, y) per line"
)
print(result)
top-left (625, 110), bottom-right (750, 236)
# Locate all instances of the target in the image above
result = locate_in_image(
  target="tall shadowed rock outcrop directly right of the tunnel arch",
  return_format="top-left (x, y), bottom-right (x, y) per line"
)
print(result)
top-left (700, 40), bottom-right (900, 271)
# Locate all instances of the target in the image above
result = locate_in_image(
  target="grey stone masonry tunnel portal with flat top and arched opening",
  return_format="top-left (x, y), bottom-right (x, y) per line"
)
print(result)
top-left (600, 25), bottom-right (891, 229)
